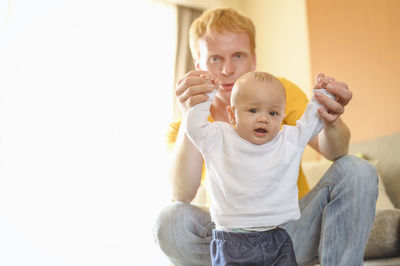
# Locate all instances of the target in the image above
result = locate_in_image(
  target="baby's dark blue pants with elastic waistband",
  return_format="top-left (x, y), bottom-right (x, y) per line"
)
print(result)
top-left (210, 227), bottom-right (297, 266)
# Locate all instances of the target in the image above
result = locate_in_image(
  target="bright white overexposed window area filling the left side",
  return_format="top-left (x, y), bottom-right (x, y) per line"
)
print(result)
top-left (0, 0), bottom-right (176, 266)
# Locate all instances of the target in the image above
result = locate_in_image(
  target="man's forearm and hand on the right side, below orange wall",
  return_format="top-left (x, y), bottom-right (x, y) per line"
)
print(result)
top-left (308, 74), bottom-right (352, 160)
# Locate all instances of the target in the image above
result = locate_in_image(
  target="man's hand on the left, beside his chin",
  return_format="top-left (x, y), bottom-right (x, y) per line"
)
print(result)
top-left (175, 70), bottom-right (217, 112)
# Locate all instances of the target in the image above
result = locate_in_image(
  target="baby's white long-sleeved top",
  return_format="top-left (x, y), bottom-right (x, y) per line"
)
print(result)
top-left (183, 90), bottom-right (323, 228)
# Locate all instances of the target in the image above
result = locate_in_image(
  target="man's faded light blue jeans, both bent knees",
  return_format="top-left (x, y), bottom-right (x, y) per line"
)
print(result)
top-left (154, 155), bottom-right (378, 266)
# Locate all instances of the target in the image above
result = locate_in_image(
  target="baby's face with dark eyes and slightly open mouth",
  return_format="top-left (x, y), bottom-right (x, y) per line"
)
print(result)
top-left (228, 78), bottom-right (286, 145)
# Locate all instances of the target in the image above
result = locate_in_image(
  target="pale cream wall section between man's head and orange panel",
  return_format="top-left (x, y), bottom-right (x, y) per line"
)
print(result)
top-left (233, 0), bottom-right (312, 96)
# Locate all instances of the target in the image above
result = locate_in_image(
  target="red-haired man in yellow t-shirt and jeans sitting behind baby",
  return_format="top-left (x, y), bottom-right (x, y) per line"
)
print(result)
top-left (154, 6), bottom-right (377, 266)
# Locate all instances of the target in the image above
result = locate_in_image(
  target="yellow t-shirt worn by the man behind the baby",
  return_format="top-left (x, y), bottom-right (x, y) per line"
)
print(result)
top-left (167, 78), bottom-right (310, 199)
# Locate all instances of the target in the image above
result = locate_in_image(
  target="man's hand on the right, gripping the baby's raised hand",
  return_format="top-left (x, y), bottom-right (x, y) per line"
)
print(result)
top-left (314, 73), bottom-right (353, 124)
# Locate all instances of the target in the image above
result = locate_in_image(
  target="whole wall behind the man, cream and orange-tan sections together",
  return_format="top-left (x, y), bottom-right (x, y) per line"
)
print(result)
top-left (170, 0), bottom-right (400, 142)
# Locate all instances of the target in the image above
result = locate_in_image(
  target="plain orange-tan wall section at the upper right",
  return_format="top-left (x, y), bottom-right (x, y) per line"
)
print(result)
top-left (307, 0), bottom-right (400, 141)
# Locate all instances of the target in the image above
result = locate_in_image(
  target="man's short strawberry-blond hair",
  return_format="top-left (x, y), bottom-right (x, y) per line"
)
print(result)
top-left (189, 8), bottom-right (256, 59)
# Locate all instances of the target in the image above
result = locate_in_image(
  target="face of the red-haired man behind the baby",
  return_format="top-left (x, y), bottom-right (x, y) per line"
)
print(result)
top-left (195, 31), bottom-right (256, 103)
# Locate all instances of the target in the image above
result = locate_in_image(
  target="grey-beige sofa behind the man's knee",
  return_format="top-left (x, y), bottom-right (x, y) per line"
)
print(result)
top-left (302, 133), bottom-right (400, 266)
